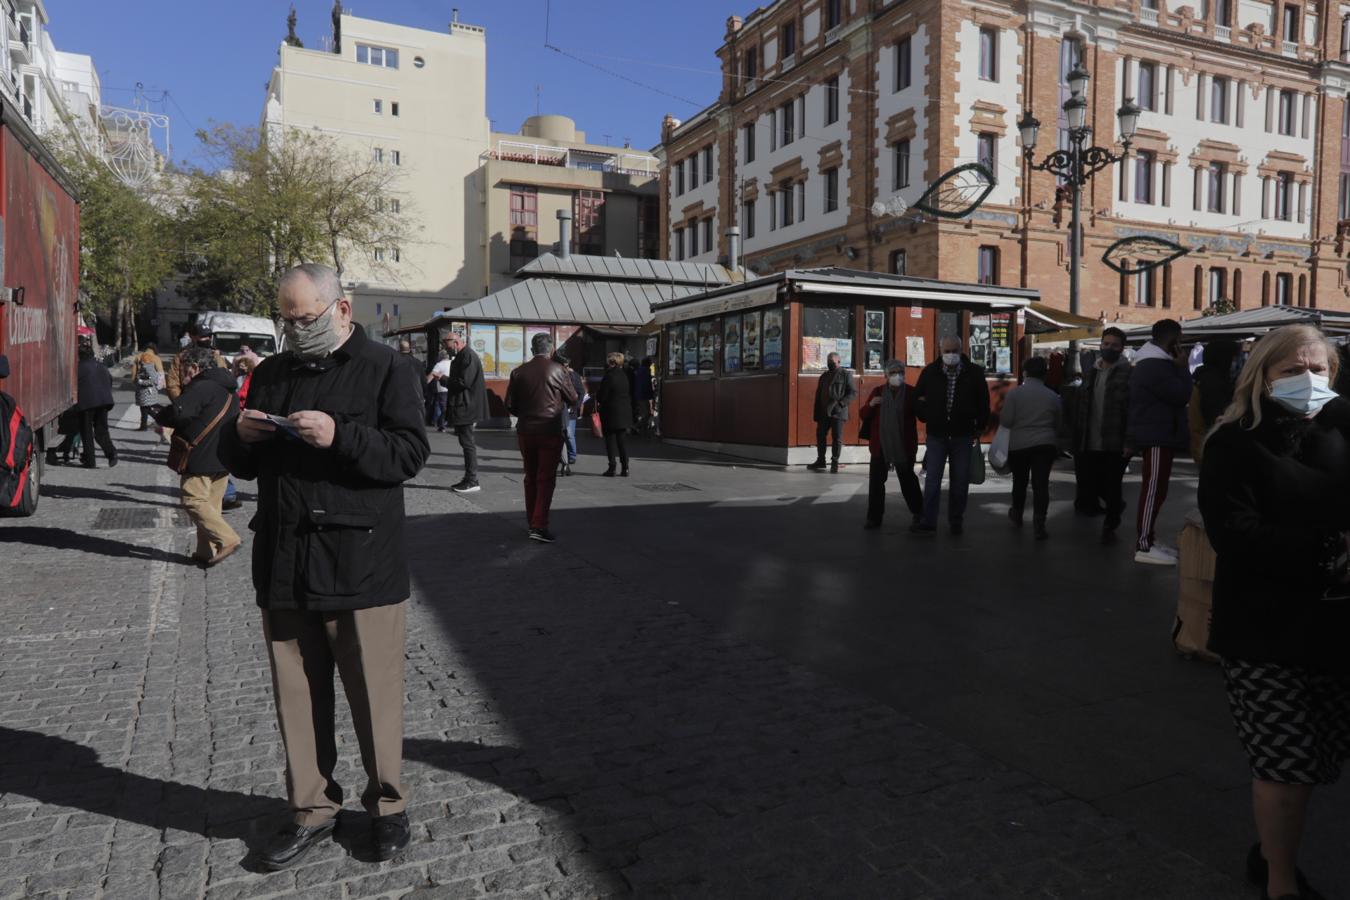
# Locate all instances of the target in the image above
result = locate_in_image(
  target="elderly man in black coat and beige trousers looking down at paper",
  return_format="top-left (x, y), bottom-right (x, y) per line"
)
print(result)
top-left (220, 264), bottom-right (431, 869)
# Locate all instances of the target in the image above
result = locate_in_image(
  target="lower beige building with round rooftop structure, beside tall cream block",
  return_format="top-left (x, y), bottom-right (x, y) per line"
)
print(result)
top-left (478, 116), bottom-right (662, 294)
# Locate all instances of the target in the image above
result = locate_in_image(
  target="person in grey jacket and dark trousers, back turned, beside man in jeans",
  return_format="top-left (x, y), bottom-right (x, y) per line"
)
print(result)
top-left (999, 356), bottom-right (1064, 541)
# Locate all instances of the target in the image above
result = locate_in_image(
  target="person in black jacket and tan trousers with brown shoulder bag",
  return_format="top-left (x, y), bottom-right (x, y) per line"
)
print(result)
top-left (155, 347), bottom-right (242, 568)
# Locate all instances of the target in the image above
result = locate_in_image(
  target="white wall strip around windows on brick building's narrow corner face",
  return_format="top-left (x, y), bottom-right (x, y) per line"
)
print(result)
top-left (956, 22), bottom-right (1022, 205)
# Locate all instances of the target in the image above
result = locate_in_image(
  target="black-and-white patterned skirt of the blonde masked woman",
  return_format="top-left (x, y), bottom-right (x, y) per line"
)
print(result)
top-left (1223, 660), bottom-right (1350, 784)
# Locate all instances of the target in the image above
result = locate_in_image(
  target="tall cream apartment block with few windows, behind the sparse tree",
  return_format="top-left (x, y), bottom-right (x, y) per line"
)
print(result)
top-left (262, 11), bottom-right (489, 334)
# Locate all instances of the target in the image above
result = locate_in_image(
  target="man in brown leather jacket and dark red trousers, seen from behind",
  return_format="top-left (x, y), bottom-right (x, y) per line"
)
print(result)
top-left (506, 335), bottom-right (576, 544)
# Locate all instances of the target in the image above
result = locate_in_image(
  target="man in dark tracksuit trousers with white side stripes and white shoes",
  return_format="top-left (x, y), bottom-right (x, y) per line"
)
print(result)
top-left (1126, 318), bottom-right (1191, 565)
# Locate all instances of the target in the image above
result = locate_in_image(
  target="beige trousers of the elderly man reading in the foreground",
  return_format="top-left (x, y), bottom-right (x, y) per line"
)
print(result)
top-left (262, 603), bottom-right (408, 826)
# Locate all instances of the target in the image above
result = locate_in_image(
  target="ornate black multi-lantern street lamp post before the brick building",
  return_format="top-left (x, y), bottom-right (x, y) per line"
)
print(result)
top-left (1017, 62), bottom-right (1141, 374)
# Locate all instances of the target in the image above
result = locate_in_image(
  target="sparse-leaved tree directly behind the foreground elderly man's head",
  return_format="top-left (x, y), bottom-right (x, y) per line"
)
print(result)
top-left (180, 125), bottom-right (412, 314)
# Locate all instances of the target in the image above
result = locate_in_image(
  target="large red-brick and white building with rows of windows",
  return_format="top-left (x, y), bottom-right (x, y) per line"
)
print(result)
top-left (662, 0), bottom-right (1350, 322)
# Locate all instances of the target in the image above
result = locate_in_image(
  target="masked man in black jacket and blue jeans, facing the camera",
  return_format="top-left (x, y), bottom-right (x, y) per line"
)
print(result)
top-left (910, 336), bottom-right (990, 534)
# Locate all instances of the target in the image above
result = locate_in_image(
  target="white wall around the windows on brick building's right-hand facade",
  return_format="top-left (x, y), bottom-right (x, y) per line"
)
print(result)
top-left (1099, 62), bottom-right (1316, 239)
